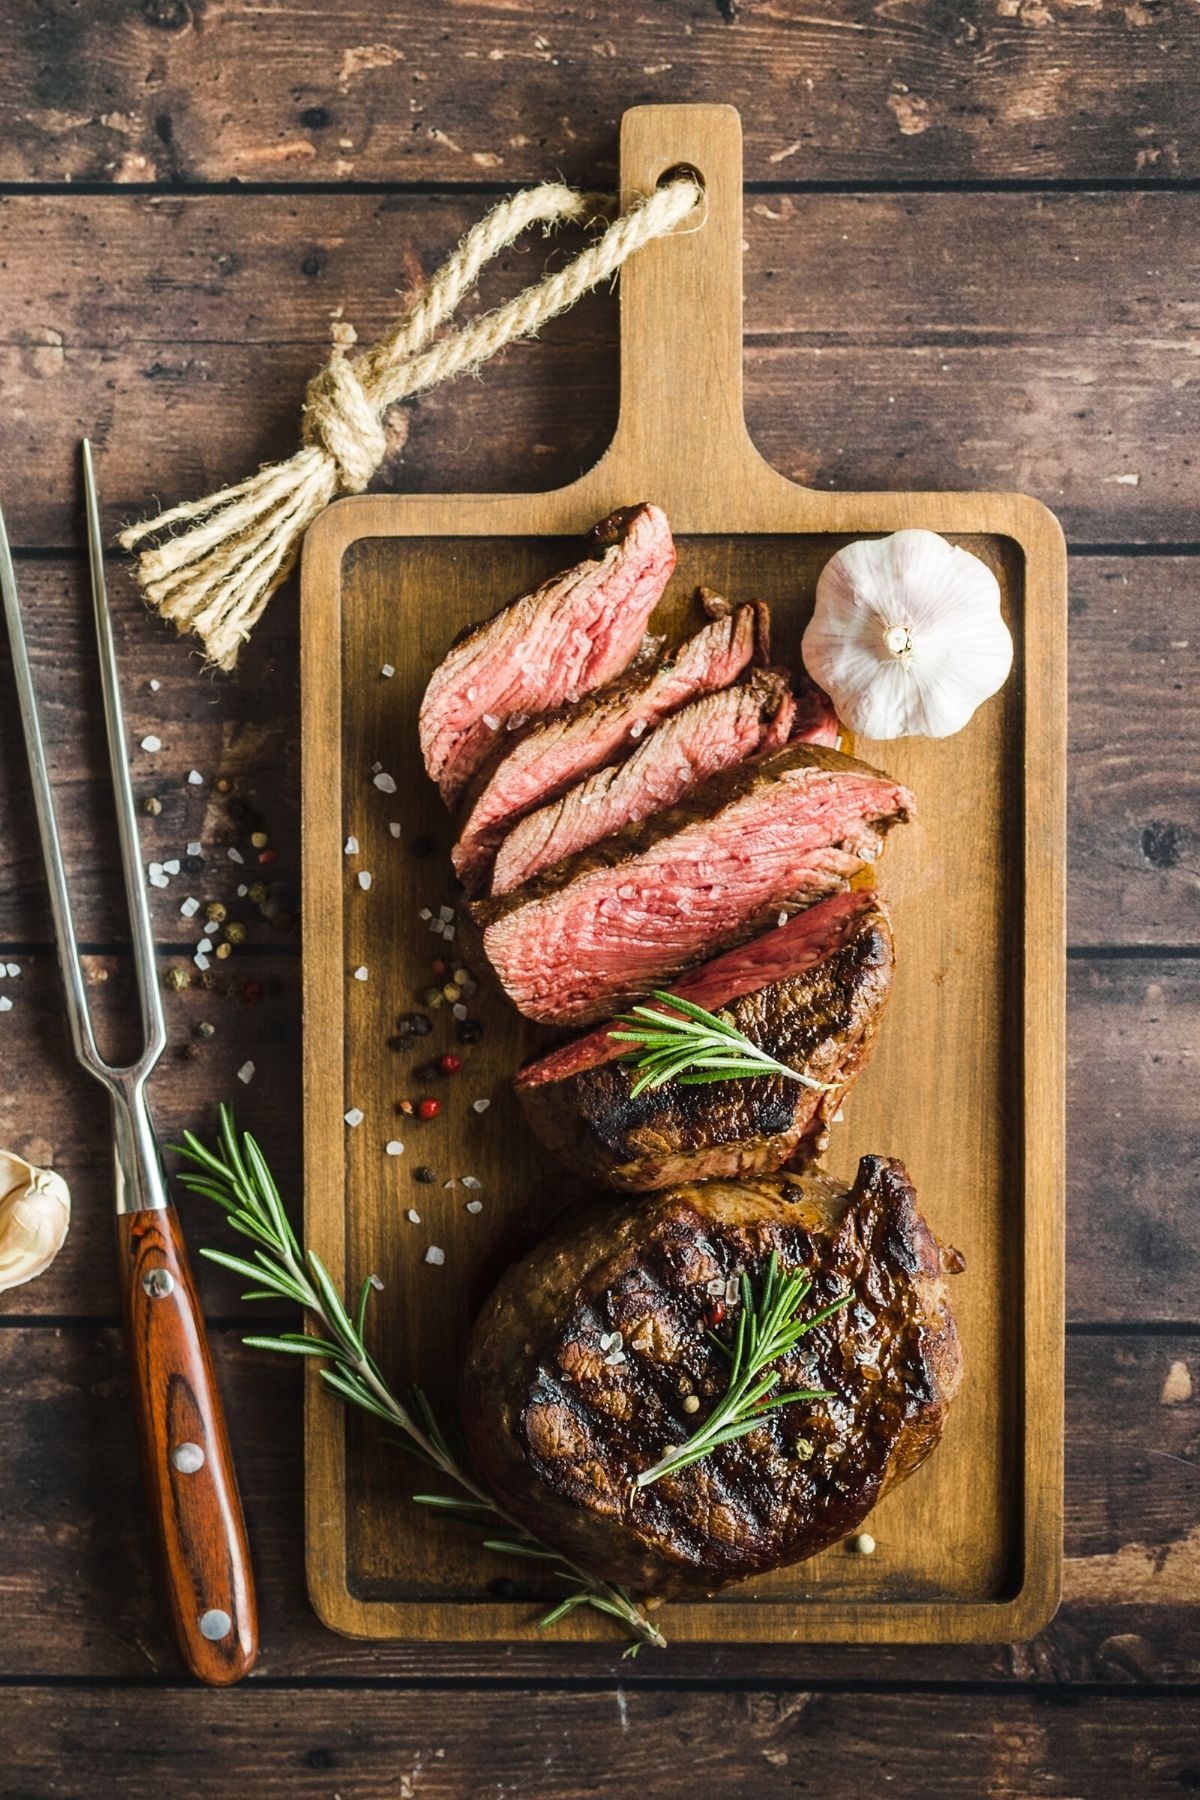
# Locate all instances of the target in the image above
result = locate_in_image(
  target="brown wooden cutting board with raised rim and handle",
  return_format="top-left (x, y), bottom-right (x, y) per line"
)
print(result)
top-left (297, 106), bottom-right (1067, 1643)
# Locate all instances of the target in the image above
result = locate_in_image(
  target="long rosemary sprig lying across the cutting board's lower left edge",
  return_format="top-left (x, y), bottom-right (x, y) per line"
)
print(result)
top-left (173, 1105), bottom-right (666, 1656)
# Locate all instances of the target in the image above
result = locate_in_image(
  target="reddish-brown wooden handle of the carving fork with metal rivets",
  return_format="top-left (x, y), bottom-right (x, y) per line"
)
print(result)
top-left (117, 1206), bottom-right (257, 1687)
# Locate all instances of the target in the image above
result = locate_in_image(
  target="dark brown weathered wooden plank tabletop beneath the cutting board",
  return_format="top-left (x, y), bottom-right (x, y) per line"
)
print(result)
top-left (0, 0), bottom-right (1200, 1800)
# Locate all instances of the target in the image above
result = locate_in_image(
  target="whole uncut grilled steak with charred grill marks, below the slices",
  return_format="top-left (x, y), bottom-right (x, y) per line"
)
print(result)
top-left (461, 1156), bottom-right (961, 1595)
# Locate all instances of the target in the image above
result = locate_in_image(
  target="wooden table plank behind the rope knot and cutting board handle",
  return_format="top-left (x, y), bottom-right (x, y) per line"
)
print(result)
top-left (0, 192), bottom-right (1200, 545)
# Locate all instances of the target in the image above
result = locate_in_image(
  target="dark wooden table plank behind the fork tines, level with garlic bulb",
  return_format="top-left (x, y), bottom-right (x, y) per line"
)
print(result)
top-left (0, 556), bottom-right (1200, 950)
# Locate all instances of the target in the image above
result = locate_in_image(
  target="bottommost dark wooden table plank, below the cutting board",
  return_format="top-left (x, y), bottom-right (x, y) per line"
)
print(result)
top-left (0, 1683), bottom-right (1200, 1800)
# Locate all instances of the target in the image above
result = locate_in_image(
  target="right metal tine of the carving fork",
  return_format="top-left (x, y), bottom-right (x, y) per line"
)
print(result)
top-left (83, 437), bottom-right (167, 1073)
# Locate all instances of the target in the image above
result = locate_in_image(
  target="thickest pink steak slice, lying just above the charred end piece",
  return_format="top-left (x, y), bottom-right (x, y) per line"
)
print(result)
top-left (470, 743), bottom-right (916, 1024)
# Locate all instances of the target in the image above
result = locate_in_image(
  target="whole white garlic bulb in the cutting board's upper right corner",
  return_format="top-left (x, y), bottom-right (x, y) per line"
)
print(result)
top-left (804, 531), bottom-right (1013, 738)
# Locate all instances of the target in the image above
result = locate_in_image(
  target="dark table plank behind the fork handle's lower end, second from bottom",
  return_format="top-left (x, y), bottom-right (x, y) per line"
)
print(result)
top-left (0, 1327), bottom-right (1200, 1684)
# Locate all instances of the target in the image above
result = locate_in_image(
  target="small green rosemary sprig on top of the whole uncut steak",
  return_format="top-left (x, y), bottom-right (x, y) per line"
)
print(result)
top-left (635, 1251), bottom-right (853, 1489)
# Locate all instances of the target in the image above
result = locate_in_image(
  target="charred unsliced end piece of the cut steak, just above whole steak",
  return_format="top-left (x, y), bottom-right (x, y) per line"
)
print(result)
top-left (516, 889), bottom-right (894, 1193)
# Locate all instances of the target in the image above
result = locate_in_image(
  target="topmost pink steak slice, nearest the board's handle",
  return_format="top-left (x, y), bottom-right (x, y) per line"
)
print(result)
top-left (419, 502), bottom-right (675, 803)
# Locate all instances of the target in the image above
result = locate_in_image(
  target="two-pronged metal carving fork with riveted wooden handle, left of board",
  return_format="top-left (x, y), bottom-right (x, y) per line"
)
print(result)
top-left (0, 439), bottom-right (257, 1687)
